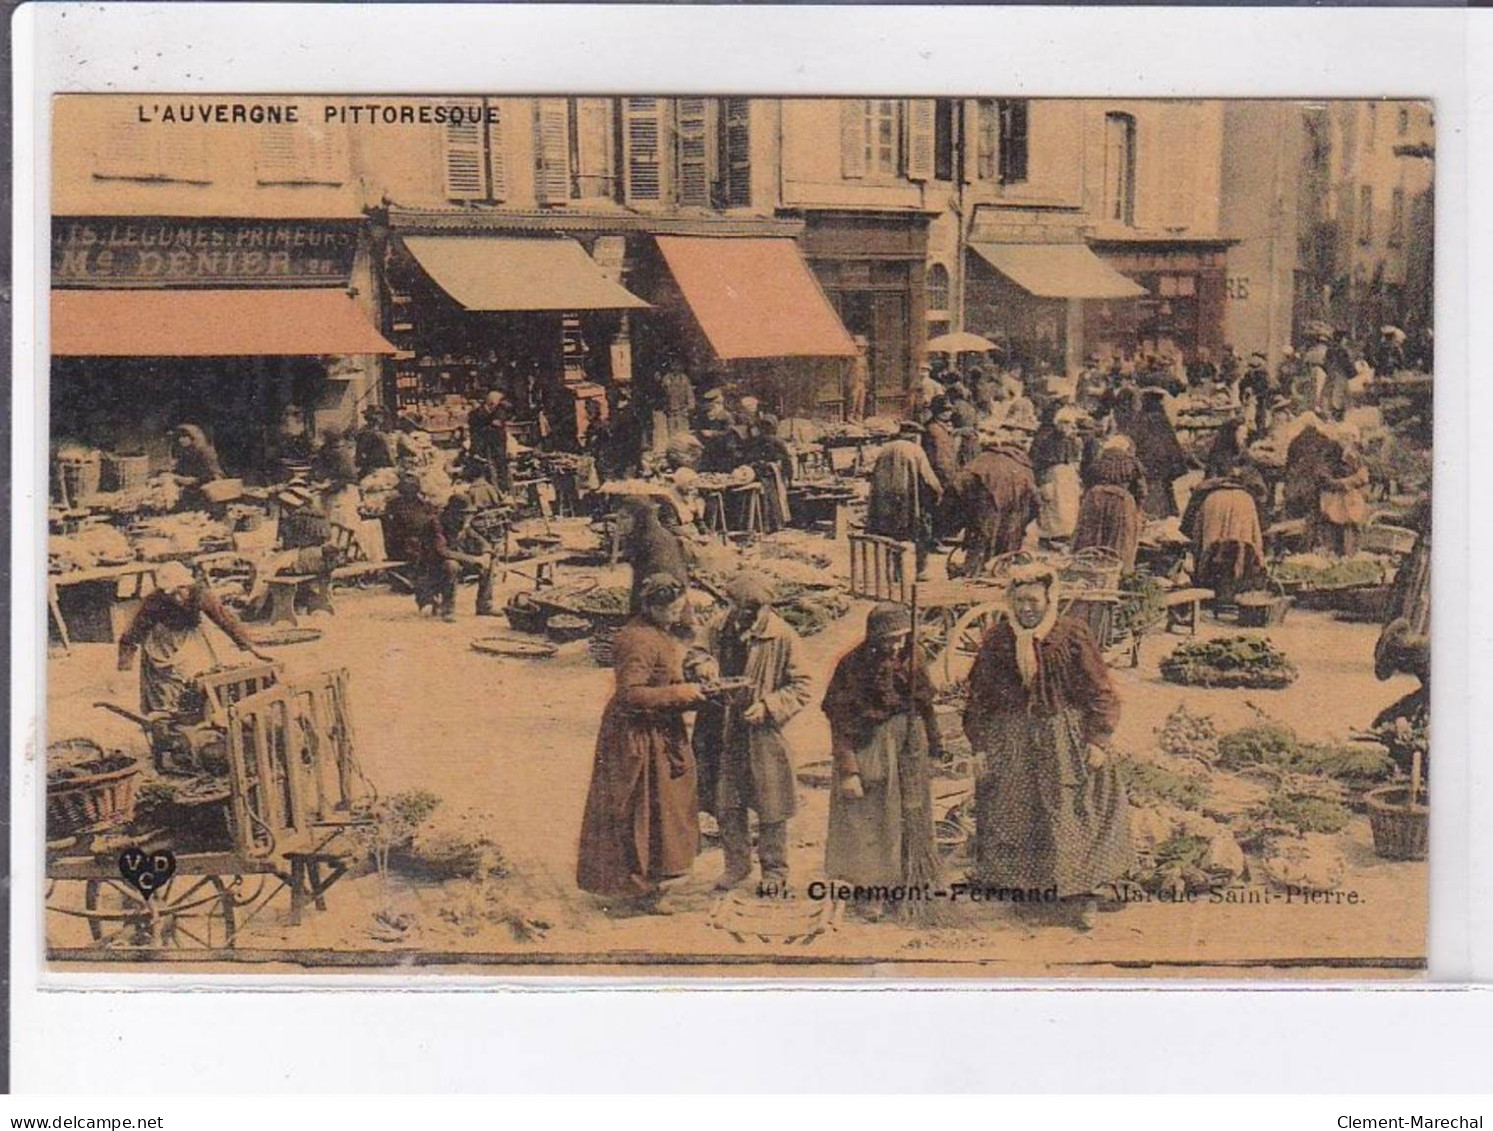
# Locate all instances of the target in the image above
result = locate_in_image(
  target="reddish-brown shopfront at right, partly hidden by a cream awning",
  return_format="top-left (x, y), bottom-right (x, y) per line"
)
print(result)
top-left (1085, 240), bottom-right (1230, 360)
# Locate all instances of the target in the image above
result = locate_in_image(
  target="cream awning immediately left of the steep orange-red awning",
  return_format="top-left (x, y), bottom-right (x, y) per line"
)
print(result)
top-left (405, 236), bottom-right (648, 310)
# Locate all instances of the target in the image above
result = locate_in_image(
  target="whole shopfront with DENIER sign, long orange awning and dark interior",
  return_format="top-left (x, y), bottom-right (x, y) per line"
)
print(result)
top-left (51, 216), bottom-right (393, 477)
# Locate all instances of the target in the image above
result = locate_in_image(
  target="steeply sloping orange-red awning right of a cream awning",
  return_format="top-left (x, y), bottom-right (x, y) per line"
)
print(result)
top-left (655, 236), bottom-right (857, 361)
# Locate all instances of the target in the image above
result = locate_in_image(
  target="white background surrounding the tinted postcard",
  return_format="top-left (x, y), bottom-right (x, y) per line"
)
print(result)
top-left (10, 4), bottom-right (1493, 1098)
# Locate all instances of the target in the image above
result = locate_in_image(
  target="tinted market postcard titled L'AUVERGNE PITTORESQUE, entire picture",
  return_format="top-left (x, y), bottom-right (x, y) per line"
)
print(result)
top-left (37, 93), bottom-right (1436, 980)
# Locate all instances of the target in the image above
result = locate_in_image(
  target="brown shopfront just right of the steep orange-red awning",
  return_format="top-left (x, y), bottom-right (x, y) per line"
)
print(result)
top-left (802, 212), bottom-right (930, 416)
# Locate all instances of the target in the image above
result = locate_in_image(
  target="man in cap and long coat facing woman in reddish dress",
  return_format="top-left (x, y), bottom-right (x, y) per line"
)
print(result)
top-left (694, 573), bottom-right (809, 891)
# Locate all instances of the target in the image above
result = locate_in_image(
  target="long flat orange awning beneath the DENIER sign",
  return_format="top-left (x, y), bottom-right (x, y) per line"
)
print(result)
top-left (52, 288), bottom-right (394, 357)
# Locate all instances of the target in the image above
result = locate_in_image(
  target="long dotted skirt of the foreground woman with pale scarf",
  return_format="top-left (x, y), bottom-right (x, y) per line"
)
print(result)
top-left (975, 710), bottom-right (1133, 898)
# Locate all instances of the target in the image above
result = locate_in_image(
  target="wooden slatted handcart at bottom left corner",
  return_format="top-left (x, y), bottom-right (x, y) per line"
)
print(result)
top-left (46, 670), bottom-right (361, 959)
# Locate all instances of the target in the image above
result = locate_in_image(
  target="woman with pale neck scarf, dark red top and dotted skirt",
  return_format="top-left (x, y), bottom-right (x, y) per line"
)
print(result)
top-left (964, 567), bottom-right (1133, 927)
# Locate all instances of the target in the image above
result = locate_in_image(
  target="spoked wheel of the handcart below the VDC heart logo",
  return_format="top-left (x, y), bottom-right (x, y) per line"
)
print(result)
top-left (82, 876), bottom-right (237, 950)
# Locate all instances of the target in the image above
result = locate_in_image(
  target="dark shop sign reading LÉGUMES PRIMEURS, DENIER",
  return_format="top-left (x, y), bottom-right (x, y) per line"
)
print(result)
top-left (52, 218), bottom-right (357, 288)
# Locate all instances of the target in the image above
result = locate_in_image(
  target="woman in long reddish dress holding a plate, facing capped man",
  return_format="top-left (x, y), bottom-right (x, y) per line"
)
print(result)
top-left (576, 573), bottom-right (705, 915)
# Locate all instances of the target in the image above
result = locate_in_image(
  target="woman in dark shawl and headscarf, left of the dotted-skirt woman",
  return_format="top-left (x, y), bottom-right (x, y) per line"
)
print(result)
top-left (823, 603), bottom-right (942, 915)
